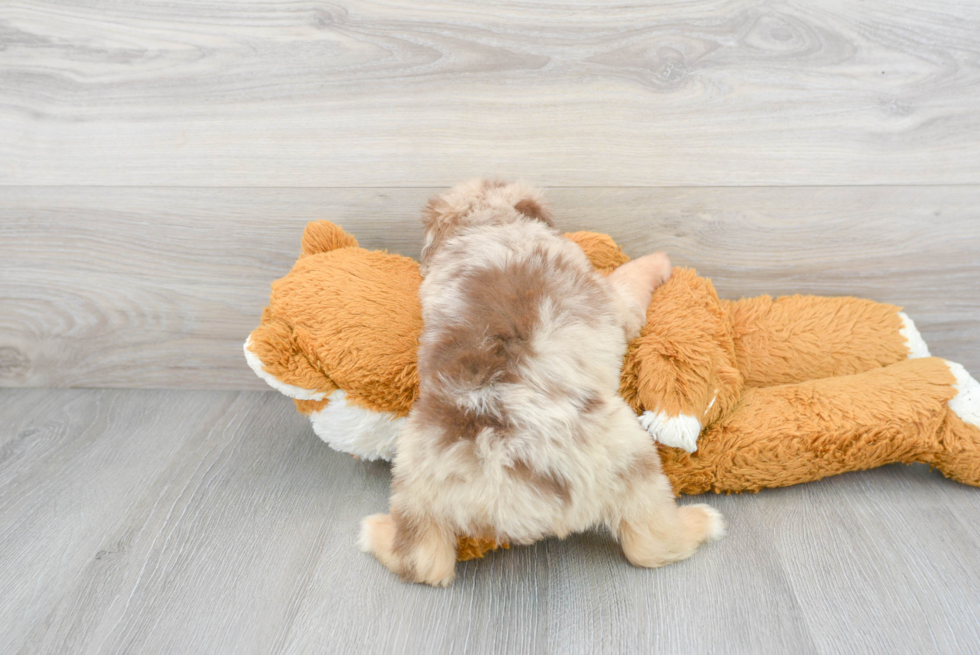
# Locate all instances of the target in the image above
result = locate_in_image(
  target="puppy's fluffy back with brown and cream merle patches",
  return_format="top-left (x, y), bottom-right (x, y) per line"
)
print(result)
top-left (419, 222), bottom-right (625, 456)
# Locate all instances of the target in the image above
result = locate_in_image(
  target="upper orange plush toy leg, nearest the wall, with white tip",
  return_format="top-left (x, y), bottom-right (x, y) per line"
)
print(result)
top-left (723, 296), bottom-right (929, 387)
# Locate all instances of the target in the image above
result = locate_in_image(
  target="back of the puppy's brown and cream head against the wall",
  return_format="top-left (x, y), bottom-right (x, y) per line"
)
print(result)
top-left (420, 179), bottom-right (554, 275)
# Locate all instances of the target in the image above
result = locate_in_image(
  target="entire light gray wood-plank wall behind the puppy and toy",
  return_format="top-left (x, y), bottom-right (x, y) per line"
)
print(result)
top-left (0, 0), bottom-right (980, 389)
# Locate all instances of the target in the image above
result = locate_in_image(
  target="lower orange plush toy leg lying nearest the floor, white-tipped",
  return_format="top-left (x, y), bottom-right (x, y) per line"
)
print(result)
top-left (661, 358), bottom-right (980, 494)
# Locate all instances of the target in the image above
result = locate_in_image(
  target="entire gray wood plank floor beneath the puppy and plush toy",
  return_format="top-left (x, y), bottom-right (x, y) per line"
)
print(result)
top-left (0, 389), bottom-right (980, 653)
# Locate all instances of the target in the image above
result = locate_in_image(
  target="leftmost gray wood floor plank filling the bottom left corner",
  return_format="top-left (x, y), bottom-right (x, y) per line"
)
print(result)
top-left (0, 390), bottom-right (227, 653)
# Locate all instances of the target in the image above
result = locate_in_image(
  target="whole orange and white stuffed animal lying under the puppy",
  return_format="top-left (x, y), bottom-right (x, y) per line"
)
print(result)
top-left (245, 221), bottom-right (980, 559)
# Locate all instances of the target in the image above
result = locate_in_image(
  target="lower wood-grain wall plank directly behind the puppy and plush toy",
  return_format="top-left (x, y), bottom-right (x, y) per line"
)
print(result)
top-left (0, 187), bottom-right (980, 389)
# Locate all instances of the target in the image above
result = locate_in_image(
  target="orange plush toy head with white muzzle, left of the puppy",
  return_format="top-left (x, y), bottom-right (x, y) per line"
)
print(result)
top-left (245, 221), bottom-right (422, 459)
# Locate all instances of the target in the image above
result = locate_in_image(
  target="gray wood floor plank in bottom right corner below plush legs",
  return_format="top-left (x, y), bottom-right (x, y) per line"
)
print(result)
top-left (758, 467), bottom-right (980, 653)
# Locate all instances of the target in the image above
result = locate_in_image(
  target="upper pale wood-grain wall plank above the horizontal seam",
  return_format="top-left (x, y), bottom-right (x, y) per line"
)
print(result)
top-left (0, 0), bottom-right (980, 187)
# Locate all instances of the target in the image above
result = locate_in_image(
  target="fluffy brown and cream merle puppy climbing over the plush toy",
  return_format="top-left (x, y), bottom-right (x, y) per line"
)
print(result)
top-left (360, 180), bottom-right (724, 586)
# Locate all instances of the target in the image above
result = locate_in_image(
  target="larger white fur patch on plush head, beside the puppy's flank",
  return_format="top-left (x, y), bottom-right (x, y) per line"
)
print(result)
top-left (310, 389), bottom-right (405, 461)
